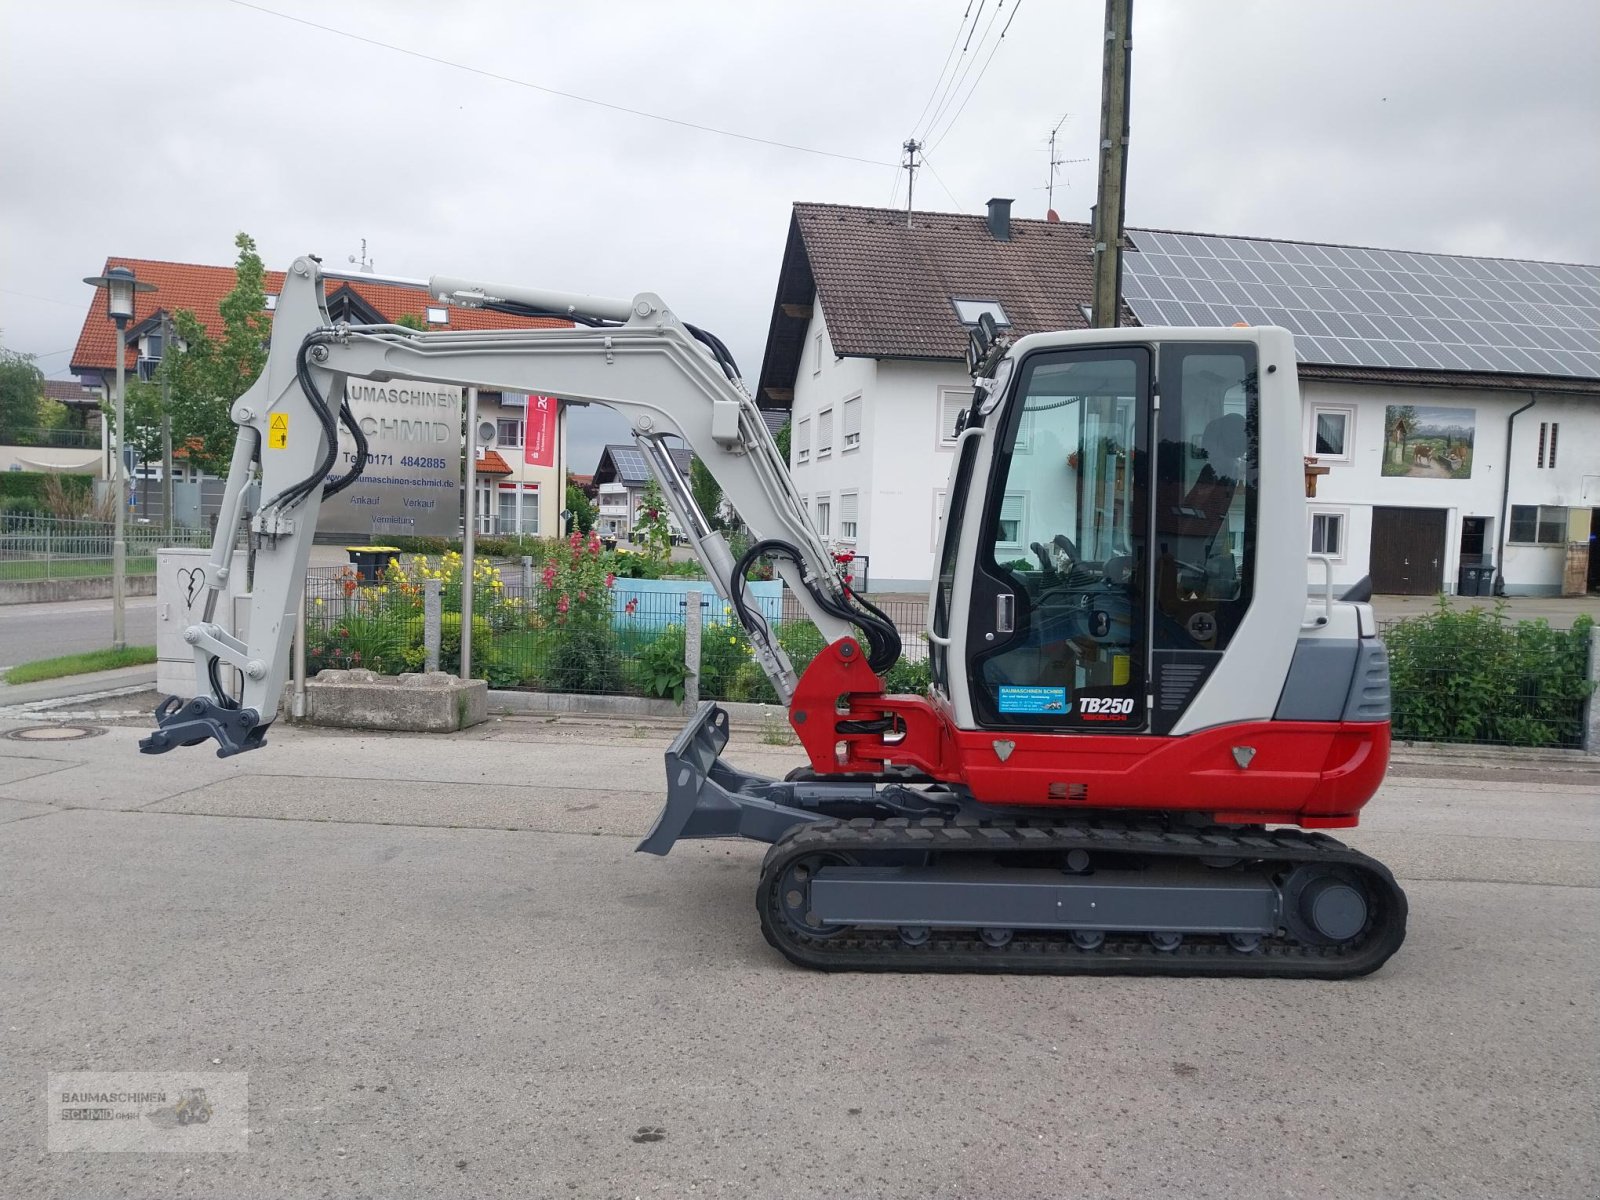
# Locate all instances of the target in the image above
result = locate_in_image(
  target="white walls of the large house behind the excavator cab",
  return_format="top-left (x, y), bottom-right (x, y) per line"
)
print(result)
top-left (790, 306), bottom-right (1600, 594)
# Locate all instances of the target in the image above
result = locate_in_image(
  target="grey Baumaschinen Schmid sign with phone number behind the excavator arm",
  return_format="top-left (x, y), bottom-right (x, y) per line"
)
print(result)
top-left (318, 379), bottom-right (461, 541)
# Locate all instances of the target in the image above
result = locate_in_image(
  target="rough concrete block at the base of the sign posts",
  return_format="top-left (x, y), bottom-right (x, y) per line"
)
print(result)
top-left (306, 667), bottom-right (490, 733)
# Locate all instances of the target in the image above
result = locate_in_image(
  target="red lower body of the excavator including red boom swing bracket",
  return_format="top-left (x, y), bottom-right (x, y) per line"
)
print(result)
top-left (789, 638), bottom-right (1389, 827)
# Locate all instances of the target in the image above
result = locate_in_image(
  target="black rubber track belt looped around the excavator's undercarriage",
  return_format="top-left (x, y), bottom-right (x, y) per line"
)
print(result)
top-left (755, 818), bottom-right (1406, 979)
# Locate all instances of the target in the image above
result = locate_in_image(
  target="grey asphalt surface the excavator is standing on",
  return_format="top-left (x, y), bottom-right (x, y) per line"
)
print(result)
top-left (0, 720), bottom-right (1600, 1200)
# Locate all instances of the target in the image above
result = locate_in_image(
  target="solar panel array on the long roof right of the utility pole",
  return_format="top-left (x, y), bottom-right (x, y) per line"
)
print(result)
top-left (1122, 230), bottom-right (1600, 378)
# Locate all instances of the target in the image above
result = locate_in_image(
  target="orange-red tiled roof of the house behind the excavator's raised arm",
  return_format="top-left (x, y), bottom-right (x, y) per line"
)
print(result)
top-left (72, 258), bottom-right (571, 373)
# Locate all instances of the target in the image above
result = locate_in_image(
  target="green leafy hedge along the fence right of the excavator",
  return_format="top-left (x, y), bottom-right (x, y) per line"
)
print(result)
top-left (1384, 597), bottom-right (1594, 746)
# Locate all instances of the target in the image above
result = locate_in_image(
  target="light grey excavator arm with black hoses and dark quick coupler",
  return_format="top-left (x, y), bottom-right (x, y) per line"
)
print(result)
top-left (141, 258), bottom-right (899, 755)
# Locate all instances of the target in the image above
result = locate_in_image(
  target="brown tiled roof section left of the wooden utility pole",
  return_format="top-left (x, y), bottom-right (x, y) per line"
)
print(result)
top-left (794, 203), bottom-right (1094, 358)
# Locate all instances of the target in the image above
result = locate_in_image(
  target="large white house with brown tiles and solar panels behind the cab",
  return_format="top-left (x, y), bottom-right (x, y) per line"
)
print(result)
top-left (757, 200), bottom-right (1600, 594)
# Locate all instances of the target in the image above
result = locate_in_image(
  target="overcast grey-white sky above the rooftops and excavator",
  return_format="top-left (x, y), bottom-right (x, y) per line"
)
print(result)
top-left (0, 0), bottom-right (1600, 470)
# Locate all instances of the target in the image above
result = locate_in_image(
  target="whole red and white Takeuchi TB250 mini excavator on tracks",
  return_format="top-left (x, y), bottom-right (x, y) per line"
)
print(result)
top-left (141, 256), bottom-right (1406, 979)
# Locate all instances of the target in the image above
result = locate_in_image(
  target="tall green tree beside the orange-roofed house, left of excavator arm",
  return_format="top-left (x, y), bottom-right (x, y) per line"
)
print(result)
top-left (157, 234), bottom-right (272, 475)
